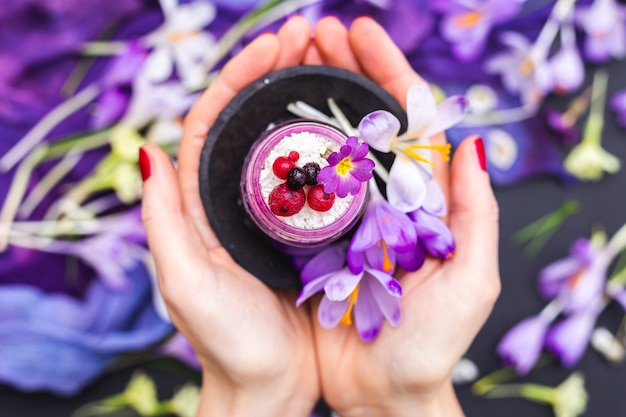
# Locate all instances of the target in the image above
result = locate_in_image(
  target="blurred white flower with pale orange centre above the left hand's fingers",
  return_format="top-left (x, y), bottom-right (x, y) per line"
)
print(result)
top-left (144, 0), bottom-right (216, 89)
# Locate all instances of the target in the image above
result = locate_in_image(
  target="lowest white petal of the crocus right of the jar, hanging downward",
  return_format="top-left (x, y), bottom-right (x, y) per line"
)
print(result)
top-left (387, 155), bottom-right (426, 213)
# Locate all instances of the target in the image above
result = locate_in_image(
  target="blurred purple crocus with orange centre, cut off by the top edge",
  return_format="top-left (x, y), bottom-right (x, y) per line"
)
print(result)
top-left (430, 0), bottom-right (521, 61)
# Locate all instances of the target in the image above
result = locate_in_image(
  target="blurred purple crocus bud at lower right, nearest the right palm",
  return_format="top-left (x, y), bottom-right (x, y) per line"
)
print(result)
top-left (496, 314), bottom-right (551, 375)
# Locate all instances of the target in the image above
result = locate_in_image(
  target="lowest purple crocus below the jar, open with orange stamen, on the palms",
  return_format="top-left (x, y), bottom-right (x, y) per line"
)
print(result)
top-left (296, 266), bottom-right (402, 342)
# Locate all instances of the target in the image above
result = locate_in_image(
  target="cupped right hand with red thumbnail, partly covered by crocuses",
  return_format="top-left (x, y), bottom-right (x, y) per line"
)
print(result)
top-left (313, 17), bottom-right (500, 417)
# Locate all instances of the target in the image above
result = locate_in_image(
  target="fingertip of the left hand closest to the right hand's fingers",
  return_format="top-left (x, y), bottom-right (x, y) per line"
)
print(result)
top-left (274, 15), bottom-right (311, 70)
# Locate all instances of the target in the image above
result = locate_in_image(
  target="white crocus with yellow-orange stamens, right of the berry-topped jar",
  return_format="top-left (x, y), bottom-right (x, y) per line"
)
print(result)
top-left (358, 83), bottom-right (468, 213)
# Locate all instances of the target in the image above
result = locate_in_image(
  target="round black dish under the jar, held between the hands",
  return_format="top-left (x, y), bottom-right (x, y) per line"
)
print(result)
top-left (199, 66), bottom-right (406, 289)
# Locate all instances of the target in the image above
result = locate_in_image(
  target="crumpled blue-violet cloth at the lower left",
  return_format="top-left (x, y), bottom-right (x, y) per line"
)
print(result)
top-left (0, 267), bottom-right (171, 395)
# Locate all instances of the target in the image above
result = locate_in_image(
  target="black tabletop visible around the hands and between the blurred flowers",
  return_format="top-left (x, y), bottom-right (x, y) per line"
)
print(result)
top-left (0, 58), bottom-right (626, 417)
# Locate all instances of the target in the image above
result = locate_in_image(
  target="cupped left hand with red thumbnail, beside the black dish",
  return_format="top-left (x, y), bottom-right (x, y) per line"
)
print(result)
top-left (141, 16), bottom-right (320, 416)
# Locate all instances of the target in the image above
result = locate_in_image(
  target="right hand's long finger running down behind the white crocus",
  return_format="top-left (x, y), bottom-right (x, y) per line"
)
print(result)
top-left (349, 16), bottom-right (449, 208)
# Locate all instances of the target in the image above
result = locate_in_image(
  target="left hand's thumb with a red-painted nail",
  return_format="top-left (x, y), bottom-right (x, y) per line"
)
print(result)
top-left (139, 144), bottom-right (202, 288)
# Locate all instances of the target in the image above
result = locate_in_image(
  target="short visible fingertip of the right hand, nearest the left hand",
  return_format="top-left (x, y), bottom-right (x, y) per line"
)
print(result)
top-left (315, 16), bottom-right (362, 73)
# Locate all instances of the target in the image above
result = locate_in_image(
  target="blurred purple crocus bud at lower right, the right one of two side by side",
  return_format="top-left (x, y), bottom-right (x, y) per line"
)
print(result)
top-left (546, 298), bottom-right (604, 368)
